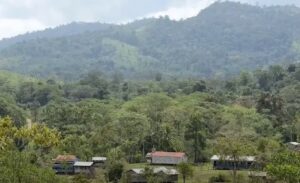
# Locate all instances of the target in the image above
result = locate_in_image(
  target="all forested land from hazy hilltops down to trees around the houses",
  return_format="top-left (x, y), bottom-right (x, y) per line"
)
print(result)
top-left (0, 2), bottom-right (300, 183)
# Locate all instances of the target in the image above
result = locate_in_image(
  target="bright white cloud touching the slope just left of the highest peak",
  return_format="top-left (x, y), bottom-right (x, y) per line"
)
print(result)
top-left (146, 0), bottom-right (216, 20)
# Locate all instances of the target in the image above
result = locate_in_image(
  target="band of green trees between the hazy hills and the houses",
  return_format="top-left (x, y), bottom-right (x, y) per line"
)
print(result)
top-left (0, 64), bottom-right (300, 182)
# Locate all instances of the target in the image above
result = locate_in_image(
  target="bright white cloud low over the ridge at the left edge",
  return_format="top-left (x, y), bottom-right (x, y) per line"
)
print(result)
top-left (0, 19), bottom-right (47, 39)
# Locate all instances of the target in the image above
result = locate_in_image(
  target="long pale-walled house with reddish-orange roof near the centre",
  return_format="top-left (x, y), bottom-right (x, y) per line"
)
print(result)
top-left (146, 151), bottom-right (187, 165)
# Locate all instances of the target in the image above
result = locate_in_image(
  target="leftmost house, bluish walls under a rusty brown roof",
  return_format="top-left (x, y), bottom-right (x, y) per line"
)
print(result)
top-left (52, 155), bottom-right (78, 174)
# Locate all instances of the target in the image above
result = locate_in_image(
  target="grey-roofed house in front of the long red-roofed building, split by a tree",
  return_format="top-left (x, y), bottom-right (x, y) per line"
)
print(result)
top-left (126, 167), bottom-right (179, 183)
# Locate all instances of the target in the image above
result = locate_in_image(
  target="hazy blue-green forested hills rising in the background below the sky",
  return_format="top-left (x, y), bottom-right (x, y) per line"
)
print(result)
top-left (0, 2), bottom-right (300, 80)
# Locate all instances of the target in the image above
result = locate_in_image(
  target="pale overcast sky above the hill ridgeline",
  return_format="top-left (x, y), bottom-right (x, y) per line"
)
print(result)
top-left (0, 0), bottom-right (300, 39)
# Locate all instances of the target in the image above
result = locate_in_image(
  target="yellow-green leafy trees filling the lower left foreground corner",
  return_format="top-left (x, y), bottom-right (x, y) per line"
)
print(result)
top-left (0, 117), bottom-right (64, 183)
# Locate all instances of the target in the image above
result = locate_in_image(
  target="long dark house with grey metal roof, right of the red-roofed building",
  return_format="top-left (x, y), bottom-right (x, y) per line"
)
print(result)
top-left (211, 155), bottom-right (256, 170)
